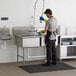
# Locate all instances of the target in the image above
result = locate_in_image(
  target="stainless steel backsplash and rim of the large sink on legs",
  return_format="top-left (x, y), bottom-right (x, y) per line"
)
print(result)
top-left (13, 27), bottom-right (44, 38)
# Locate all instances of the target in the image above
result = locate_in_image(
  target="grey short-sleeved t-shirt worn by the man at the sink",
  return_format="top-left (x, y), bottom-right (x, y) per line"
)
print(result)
top-left (46, 17), bottom-right (57, 40)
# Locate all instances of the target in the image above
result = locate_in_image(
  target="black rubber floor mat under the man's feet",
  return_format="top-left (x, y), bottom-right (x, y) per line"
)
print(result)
top-left (19, 63), bottom-right (76, 73)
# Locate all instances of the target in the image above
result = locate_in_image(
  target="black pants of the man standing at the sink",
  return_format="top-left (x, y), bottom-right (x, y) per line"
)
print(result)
top-left (46, 40), bottom-right (57, 63)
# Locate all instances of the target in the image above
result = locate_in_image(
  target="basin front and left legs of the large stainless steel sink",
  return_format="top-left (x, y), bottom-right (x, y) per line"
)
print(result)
top-left (15, 36), bottom-right (44, 65)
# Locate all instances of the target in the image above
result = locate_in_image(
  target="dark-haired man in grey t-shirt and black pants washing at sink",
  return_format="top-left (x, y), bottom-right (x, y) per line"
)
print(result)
top-left (40, 9), bottom-right (57, 66)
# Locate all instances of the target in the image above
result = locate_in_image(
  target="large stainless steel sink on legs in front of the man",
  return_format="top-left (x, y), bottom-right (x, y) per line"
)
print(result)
top-left (13, 27), bottom-right (44, 64)
